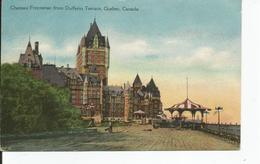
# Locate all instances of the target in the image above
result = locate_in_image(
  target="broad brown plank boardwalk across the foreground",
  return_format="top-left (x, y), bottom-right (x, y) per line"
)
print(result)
top-left (4, 125), bottom-right (239, 151)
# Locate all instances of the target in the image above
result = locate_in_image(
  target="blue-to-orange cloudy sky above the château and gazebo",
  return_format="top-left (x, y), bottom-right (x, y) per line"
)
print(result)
top-left (1, 0), bottom-right (241, 123)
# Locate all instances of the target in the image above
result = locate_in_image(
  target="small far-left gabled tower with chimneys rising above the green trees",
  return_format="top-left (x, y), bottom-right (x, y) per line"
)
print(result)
top-left (18, 40), bottom-right (42, 78)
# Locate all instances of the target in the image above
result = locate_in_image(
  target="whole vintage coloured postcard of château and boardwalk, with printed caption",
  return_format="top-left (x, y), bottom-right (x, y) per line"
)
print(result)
top-left (1, 0), bottom-right (241, 151)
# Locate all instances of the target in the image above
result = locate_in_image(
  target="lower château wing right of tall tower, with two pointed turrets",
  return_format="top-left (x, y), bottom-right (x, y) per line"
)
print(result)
top-left (103, 75), bottom-right (162, 122)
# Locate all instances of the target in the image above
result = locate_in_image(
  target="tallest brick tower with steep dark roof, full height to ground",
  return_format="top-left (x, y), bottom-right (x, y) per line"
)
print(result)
top-left (76, 19), bottom-right (110, 123)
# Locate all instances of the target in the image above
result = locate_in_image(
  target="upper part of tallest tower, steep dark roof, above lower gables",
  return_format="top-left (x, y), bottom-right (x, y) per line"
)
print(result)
top-left (76, 19), bottom-right (110, 85)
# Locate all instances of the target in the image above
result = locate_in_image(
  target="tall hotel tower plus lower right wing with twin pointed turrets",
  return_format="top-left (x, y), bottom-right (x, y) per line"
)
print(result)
top-left (73, 20), bottom-right (162, 122)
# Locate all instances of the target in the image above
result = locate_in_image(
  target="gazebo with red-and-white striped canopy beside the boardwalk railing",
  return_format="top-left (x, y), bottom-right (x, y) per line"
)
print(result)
top-left (164, 97), bottom-right (211, 122)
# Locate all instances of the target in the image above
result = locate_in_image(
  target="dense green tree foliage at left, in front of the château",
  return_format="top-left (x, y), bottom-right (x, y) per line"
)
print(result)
top-left (0, 64), bottom-right (87, 134)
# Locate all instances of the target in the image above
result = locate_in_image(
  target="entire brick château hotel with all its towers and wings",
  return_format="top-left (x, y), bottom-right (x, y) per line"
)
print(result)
top-left (19, 19), bottom-right (162, 123)
